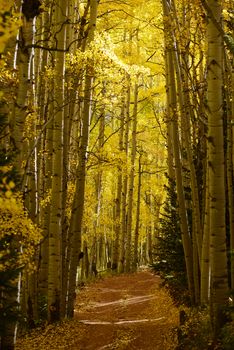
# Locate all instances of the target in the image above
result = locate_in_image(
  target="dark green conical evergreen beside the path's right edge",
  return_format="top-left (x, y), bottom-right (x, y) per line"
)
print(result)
top-left (151, 179), bottom-right (189, 303)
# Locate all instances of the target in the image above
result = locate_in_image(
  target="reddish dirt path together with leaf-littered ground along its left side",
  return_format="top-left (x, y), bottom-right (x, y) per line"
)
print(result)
top-left (16, 270), bottom-right (178, 350)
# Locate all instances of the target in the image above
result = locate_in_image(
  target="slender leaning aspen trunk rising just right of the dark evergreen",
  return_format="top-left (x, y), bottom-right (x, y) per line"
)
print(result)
top-left (170, 4), bottom-right (202, 303)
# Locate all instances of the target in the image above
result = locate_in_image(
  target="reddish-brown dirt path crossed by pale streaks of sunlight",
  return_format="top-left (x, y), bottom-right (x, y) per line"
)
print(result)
top-left (75, 271), bottom-right (178, 350)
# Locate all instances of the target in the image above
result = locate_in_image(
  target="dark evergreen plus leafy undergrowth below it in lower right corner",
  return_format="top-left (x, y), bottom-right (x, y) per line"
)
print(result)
top-left (150, 179), bottom-right (234, 350)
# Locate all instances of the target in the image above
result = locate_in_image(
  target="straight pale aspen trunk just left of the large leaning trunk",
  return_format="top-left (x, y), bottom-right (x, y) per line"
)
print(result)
top-left (48, 0), bottom-right (67, 322)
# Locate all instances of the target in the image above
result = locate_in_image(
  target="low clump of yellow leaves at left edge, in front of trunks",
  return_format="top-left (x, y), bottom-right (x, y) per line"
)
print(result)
top-left (0, 185), bottom-right (42, 271)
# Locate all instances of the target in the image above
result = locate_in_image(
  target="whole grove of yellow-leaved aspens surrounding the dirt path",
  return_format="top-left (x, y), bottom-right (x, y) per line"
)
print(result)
top-left (0, 0), bottom-right (234, 349)
